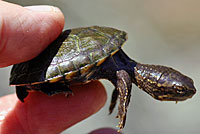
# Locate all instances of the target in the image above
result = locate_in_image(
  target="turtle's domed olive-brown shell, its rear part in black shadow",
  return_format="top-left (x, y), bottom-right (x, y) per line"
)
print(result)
top-left (10, 26), bottom-right (127, 85)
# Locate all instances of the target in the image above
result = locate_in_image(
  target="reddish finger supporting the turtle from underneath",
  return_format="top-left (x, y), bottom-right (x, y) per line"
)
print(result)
top-left (0, 81), bottom-right (106, 134)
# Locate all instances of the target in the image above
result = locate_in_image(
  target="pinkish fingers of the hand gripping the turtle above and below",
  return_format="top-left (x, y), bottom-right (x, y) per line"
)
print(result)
top-left (0, 1), bottom-right (119, 134)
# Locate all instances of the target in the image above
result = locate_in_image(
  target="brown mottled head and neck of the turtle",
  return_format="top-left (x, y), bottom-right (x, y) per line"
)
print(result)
top-left (135, 64), bottom-right (196, 101)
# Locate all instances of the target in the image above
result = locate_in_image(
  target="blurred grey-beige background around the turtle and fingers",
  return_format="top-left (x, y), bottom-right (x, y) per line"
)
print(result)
top-left (0, 0), bottom-right (200, 134)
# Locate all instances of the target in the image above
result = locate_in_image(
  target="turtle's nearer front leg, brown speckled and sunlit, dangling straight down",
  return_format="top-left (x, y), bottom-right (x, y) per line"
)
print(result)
top-left (116, 70), bottom-right (132, 131)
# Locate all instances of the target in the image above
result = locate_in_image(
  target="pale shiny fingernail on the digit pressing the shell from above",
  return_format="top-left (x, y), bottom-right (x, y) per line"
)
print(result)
top-left (25, 5), bottom-right (60, 12)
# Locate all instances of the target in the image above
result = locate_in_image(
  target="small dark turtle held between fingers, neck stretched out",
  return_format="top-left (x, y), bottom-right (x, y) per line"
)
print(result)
top-left (10, 26), bottom-right (196, 130)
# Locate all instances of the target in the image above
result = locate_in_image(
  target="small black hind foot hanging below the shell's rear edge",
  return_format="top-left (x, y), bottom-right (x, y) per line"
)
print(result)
top-left (16, 86), bottom-right (28, 102)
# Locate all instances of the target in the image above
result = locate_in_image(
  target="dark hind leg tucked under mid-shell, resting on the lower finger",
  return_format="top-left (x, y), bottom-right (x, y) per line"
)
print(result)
top-left (40, 82), bottom-right (73, 96)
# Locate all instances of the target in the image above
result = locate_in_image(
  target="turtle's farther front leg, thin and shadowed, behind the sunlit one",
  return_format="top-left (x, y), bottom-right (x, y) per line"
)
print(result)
top-left (109, 88), bottom-right (119, 114)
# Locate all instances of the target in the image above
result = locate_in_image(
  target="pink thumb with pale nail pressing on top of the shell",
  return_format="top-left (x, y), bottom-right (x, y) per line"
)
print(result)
top-left (0, 1), bottom-right (64, 67)
